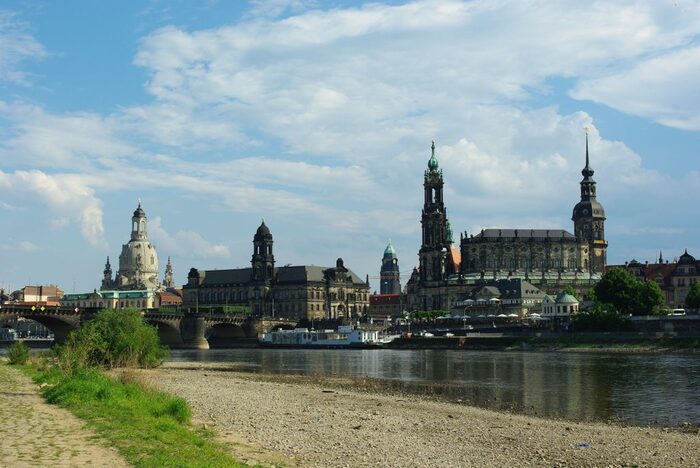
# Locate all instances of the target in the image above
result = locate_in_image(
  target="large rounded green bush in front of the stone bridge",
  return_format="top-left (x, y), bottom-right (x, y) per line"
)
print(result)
top-left (56, 309), bottom-right (168, 372)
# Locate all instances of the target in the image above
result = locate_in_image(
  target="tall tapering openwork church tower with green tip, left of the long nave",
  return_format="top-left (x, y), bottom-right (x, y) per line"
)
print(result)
top-left (418, 141), bottom-right (449, 285)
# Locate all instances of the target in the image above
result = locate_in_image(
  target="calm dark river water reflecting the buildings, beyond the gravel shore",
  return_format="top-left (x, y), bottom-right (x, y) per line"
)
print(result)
top-left (171, 348), bottom-right (700, 426)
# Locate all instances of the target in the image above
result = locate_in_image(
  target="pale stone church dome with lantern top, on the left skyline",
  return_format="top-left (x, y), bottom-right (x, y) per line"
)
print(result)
top-left (116, 200), bottom-right (160, 290)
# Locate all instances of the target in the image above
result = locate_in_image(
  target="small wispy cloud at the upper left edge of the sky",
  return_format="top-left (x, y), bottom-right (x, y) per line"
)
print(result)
top-left (0, 10), bottom-right (46, 84)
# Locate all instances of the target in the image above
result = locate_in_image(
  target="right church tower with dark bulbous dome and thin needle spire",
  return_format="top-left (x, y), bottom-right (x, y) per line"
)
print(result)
top-left (571, 129), bottom-right (608, 275)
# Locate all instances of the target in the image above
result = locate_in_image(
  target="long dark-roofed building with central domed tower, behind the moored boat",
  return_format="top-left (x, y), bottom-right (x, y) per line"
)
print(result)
top-left (183, 221), bottom-right (369, 319)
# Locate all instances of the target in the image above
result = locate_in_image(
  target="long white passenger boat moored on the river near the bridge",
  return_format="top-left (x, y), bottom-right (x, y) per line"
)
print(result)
top-left (259, 325), bottom-right (384, 348)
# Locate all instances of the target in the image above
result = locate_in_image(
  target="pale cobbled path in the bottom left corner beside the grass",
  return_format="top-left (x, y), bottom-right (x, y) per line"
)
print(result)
top-left (0, 362), bottom-right (129, 467)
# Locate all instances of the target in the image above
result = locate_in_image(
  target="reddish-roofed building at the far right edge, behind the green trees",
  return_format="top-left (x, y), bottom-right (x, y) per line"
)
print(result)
top-left (608, 250), bottom-right (700, 309)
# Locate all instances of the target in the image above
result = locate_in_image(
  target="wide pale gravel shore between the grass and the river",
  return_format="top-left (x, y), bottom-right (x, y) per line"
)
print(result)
top-left (134, 363), bottom-right (700, 467)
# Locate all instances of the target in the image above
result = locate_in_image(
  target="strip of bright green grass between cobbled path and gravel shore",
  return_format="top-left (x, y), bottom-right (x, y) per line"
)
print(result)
top-left (22, 366), bottom-right (246, 467)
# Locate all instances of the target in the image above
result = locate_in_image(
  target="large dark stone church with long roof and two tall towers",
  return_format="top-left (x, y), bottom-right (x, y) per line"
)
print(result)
top-left (406, 133), bottom-right (608, 310)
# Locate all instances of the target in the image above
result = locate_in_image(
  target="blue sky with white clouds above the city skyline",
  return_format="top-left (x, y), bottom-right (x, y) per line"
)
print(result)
top-left (0, 0), bottom-right (700, 292)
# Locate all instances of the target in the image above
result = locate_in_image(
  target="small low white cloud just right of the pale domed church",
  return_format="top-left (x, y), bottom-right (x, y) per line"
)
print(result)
top-left (148, 216), bottom-right (231, 259)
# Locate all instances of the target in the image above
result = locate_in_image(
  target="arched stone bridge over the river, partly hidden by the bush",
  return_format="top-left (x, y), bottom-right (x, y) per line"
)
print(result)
top-left (0, 304), bottom-right (297, 349)
